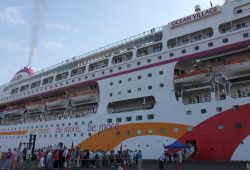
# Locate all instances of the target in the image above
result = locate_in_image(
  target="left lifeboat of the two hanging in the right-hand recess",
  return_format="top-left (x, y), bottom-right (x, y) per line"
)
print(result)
top-left (174, 70), bottom-right (213, 84)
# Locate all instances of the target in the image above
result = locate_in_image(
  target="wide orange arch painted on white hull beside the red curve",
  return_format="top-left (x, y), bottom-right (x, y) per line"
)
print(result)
top-left (78, 123), bottom-right (190, 150)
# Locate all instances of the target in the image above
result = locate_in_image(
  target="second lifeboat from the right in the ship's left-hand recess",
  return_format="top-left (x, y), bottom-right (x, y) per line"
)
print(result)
top-left (45, 97), bottom-right (69, 110)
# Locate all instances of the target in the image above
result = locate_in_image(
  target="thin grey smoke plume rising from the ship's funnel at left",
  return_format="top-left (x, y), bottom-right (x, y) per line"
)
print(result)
top-left (28, 0), bottom-right (47, 66)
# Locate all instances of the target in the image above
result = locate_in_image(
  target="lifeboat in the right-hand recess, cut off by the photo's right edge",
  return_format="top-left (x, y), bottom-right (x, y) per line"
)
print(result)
top-left (221, 60), bottom-right (250, 79)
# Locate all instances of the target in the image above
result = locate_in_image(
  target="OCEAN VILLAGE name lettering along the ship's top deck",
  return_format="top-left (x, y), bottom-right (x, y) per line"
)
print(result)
top-left (171, 7), bottom-right (219, 28)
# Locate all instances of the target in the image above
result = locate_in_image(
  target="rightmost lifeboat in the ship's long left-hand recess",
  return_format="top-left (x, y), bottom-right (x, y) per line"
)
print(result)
top-left (70, 90), bottom-right (98, 106)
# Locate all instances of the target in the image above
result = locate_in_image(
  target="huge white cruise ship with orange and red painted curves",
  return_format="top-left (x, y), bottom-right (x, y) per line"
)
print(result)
top-left (0, 0), bottom-right (250, 160)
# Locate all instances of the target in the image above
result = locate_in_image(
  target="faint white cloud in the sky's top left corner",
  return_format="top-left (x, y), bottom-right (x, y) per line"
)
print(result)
top-left (0, 6), bottom-right (26, 25)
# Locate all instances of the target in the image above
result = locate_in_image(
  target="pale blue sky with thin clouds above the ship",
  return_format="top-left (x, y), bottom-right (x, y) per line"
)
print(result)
top-left (0, 0), bottom-right (222, 84)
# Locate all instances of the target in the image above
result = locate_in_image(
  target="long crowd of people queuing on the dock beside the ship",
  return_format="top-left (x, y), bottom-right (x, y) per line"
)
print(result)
top-left (2, 147), bottom-right (142, 170)
